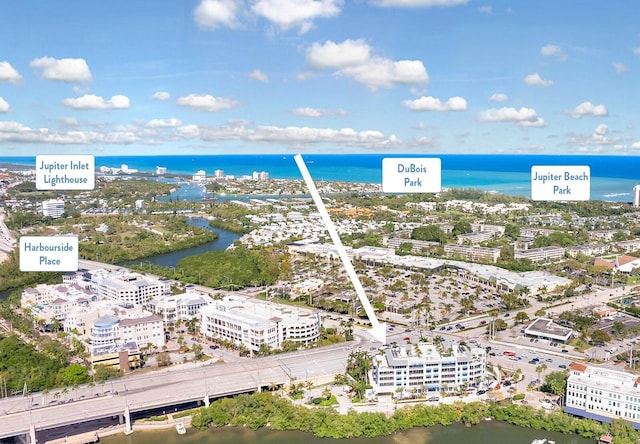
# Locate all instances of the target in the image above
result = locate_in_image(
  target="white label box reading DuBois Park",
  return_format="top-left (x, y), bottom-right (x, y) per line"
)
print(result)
top-left (382, 157), bottom-right (442, 193)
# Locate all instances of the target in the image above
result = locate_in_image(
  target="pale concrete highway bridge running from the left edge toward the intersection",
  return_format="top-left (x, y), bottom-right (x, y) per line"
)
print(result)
top-left (0, 344), bottom-right (356, 438)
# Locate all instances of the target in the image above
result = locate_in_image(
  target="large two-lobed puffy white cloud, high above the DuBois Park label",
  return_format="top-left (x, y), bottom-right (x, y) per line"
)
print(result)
top-left (307, 40), bottom-right (429, 91)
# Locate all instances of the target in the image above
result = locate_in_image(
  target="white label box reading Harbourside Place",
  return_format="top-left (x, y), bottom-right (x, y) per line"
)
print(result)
top-left (19, 236), bottom-right (78, 271)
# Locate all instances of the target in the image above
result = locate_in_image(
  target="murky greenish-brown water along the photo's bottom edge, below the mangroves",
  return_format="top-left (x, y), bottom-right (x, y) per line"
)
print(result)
top-left (101, 421), bottom-right (595, 444)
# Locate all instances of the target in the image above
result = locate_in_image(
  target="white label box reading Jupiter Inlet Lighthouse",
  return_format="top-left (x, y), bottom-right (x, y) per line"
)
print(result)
top-left (36, 154), bottom-right (96, 190)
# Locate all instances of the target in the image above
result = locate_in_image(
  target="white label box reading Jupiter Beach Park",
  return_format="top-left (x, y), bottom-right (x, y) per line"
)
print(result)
top-left (531, 165), bottom-right (591, 201)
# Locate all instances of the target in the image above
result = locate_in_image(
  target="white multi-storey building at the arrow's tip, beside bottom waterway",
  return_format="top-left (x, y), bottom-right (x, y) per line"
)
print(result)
top-left (371, 343), bottom-right (487, 394)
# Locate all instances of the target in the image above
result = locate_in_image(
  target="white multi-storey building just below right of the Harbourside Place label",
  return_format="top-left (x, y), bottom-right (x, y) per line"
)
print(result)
top-left (91, 270), bottom-right (171, 305)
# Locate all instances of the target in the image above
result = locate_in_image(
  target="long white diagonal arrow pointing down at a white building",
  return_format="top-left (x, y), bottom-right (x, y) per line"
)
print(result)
top-left (293, 154), bottom-right (387, 344)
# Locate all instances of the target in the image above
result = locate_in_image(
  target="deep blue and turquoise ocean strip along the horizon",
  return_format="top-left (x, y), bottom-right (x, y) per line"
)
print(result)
top-left (0, 154), bottom-right (640, 202)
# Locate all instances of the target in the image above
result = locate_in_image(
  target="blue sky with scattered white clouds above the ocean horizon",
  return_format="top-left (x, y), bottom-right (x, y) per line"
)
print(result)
top-left (0, 0), bottom-right (640, 156)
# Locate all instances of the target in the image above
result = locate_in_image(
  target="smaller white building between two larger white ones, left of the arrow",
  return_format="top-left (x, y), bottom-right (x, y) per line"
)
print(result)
top-left (145, 287), bottom-right (213, 327)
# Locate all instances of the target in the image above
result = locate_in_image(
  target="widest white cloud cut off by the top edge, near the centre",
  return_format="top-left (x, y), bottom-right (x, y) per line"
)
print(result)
top-left (251, 0), bottom-right (343, 34)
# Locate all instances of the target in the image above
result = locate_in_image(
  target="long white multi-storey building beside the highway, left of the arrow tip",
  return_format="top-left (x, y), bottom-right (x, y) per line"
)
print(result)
top-left (200, 296), bottom-right (321, 352)
